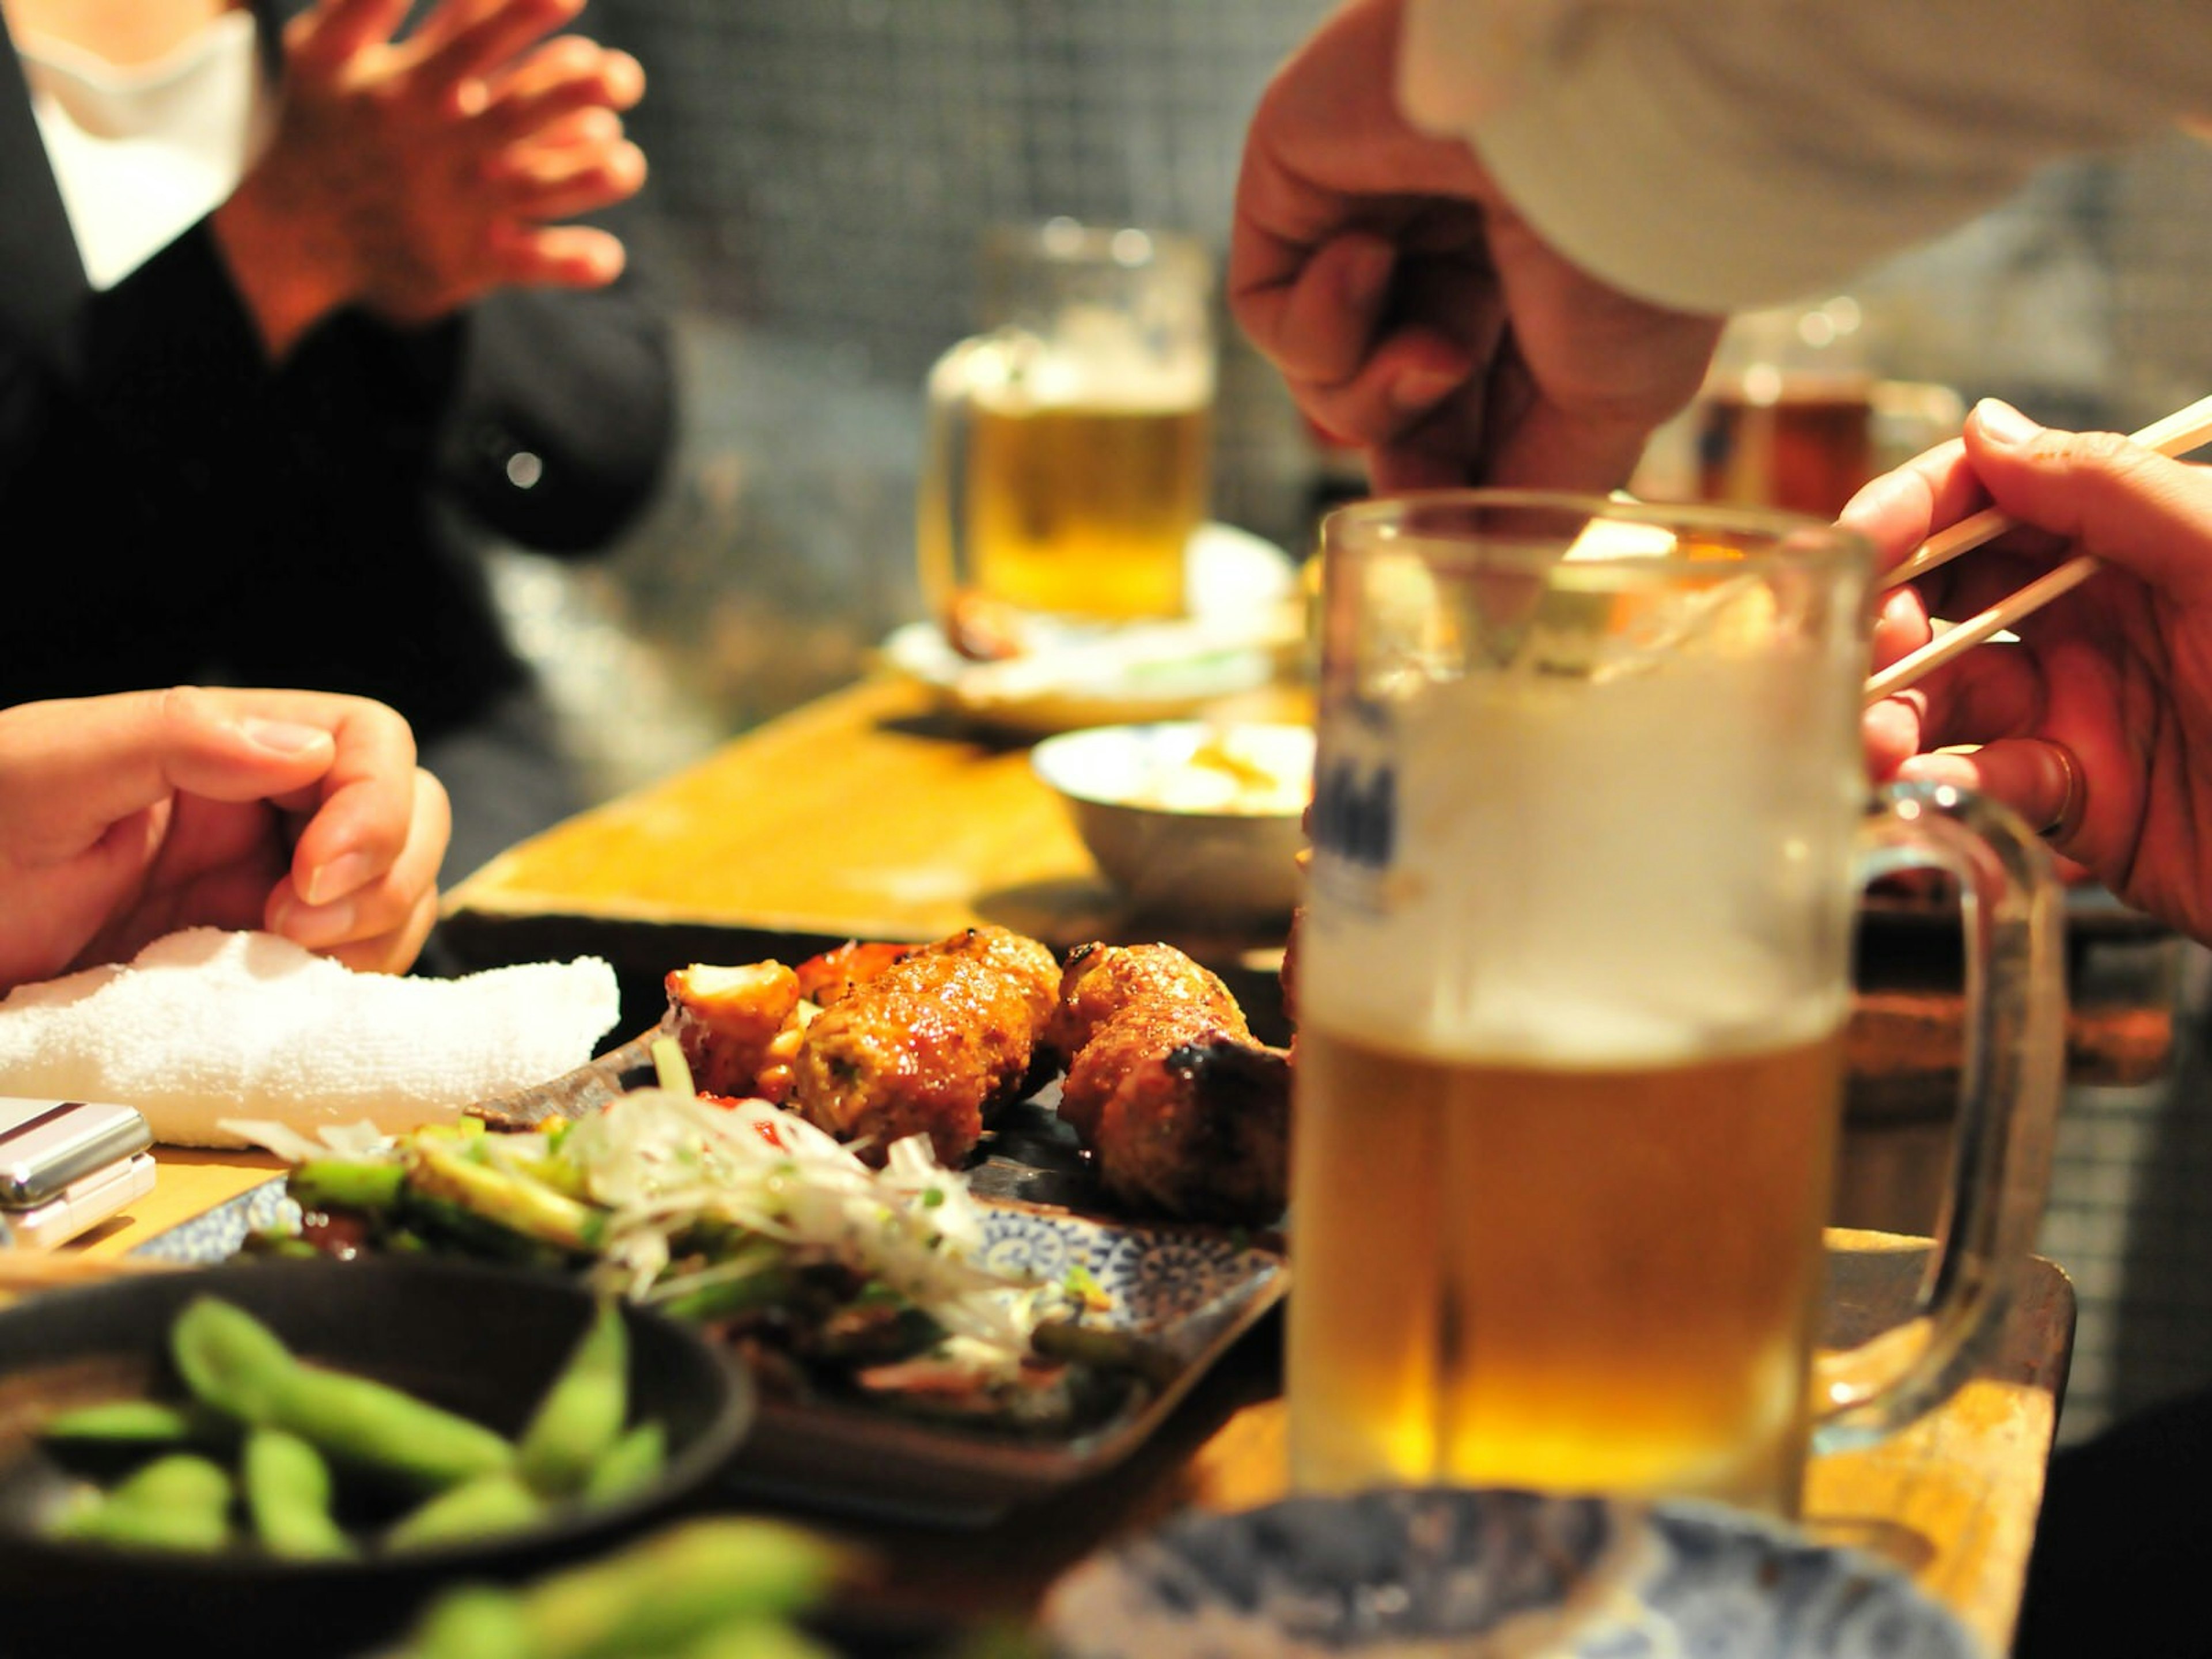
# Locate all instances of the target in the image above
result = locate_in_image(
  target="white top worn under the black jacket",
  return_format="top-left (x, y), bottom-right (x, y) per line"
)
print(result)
top-left (16, 11), bottom-right (274, 287)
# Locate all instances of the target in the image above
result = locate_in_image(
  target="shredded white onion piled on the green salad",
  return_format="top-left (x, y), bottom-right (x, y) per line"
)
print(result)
top-left (232, 1040), bottom-right (1066, 1358)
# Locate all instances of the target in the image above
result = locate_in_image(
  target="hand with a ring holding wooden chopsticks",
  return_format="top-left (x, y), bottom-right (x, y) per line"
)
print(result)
top-left (1840, 403), bottom-right (2212, 940)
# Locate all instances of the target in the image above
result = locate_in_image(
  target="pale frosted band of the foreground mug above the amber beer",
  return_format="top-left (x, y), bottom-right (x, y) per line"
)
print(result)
top-left (1298, 646), bottom-right (1865, 1064)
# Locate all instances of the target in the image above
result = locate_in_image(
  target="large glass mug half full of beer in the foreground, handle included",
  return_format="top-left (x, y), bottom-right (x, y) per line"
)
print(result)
top-left (1290, 491), bottom-right (2064, 1515)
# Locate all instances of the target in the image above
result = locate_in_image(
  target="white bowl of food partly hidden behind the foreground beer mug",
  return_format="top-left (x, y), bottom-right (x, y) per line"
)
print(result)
top-left (1031, 721), bottom-right (1314, 925)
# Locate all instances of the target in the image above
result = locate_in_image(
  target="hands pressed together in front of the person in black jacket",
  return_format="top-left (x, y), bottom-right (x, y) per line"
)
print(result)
top-left (213, 0), bottom-right (646, 358)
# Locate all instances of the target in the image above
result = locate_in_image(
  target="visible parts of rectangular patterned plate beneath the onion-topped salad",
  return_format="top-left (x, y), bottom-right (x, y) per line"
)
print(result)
top-left (132, 1179), bottom-right (1290, 1522)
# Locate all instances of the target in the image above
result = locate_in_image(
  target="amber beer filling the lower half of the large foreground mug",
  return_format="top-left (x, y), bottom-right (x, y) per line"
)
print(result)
top-left (1290, 1011), bottom-right (1840, 1515)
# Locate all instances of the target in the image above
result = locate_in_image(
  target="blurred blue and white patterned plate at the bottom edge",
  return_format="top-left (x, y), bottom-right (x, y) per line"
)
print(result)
top-left (1044, 1488), bottom-right (1980, 1659)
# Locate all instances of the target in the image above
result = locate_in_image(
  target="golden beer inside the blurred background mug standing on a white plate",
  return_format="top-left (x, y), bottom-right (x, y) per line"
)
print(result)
top-left (967, 396), bottom-right (1212, 622)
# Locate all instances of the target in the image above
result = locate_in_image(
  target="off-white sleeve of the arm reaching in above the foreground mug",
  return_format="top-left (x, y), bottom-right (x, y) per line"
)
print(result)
top-left (1398, 0), bottom-right (2212, 312)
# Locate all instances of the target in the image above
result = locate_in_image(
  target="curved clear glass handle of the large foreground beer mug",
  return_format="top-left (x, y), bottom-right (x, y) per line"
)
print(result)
top-left (1814, 783), bottom-right (2066, 1451)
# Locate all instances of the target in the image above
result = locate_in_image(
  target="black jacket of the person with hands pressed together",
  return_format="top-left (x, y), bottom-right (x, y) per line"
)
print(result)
top-left (0, 0), bottom-right (672, 876)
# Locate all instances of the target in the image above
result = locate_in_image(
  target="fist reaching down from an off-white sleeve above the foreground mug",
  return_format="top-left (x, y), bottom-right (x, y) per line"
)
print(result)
top-left (1228, 0), bottom-right (1723, 489)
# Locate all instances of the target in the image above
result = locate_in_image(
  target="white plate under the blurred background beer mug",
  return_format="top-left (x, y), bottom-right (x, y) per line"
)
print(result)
top-left (882, 524), bottom-right (1303, 737)
